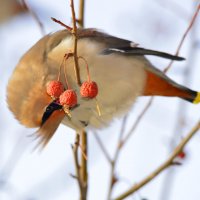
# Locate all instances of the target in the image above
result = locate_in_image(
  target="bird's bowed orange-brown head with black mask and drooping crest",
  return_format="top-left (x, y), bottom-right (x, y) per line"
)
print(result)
top-left (7, 70), bottom-right (65, 146)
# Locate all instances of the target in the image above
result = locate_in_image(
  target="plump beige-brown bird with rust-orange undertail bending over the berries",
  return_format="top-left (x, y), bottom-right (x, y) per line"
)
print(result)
top-left (7, 28), bottom-right (200, 146)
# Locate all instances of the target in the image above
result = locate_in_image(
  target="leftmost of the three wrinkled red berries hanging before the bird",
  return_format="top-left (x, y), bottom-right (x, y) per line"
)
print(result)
top-left (47, 81), bottom-right (64, 98)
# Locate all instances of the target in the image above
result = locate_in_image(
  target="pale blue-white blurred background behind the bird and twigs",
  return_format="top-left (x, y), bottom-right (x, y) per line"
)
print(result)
top-left (0, 0), bottom-right (200, 200)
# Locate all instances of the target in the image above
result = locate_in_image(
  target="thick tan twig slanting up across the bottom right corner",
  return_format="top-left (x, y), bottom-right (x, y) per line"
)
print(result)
top-left (114, 121), bottom-right (200, 200)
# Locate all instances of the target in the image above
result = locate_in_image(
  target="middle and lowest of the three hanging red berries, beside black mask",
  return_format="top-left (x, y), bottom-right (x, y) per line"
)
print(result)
top-left (59, 89), bottom-right (77, 108)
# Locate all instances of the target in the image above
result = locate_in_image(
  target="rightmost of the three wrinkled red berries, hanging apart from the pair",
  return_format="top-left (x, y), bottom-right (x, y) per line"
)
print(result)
top-left (80, 81), bottom-right (98, 98)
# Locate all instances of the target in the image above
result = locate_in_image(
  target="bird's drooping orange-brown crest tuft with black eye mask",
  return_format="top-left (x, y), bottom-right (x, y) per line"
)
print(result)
top-left (35, 102), bottom-right (65, 148)
